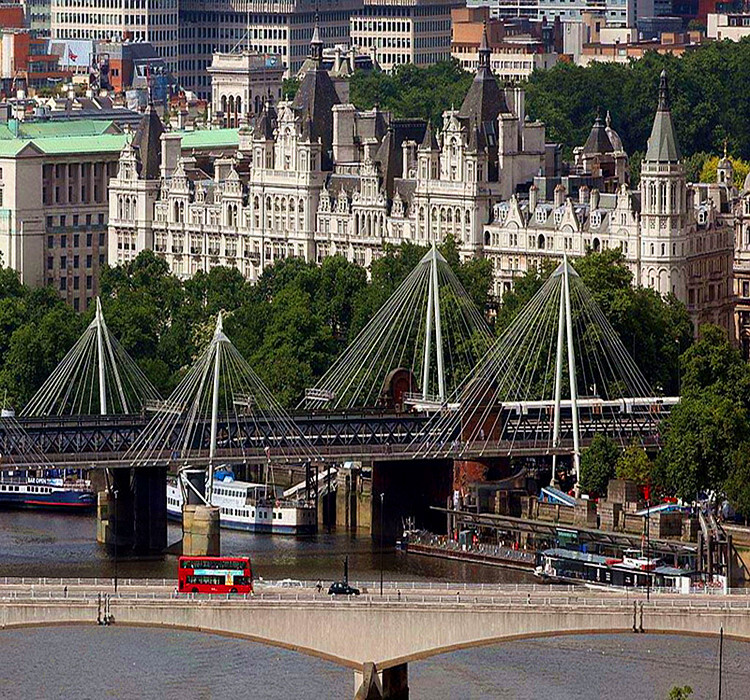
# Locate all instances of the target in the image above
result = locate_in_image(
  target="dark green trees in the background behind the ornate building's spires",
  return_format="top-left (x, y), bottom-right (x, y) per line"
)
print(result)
top-left (350, 39), bottom-right (750, 160)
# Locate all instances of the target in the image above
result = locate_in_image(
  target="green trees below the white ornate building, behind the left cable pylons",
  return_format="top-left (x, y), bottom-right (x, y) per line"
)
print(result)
top-left (0, 239), bottom-right (492, 409)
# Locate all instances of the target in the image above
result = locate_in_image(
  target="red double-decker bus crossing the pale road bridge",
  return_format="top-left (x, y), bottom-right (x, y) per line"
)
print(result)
top-left (177, 557), bottom-right (253, 593)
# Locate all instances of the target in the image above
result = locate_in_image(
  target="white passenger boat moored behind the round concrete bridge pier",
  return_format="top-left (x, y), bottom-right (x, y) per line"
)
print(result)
top-left (167, 472), bottom-right (318, 535)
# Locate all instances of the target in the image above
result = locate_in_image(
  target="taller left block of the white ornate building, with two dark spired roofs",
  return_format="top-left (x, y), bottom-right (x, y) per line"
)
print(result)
top-left (109, 32), bottom-right (545, 279)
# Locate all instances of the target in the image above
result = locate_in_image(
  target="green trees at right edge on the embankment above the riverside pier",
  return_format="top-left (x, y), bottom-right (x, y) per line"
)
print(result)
top-left (581, 326), bottom-right (750, 517)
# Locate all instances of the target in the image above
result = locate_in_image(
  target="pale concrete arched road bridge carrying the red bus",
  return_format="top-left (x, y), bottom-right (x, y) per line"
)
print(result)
top-left (0, 585), bottom-right (750, 700)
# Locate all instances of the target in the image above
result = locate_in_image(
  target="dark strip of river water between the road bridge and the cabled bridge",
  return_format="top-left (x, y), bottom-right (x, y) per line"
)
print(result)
top-left (0, 511), bottom-right (532, 583)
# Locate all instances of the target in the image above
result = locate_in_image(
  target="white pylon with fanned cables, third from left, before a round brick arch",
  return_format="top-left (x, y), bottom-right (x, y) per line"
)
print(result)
top-left (299, 243), bottom-right (492, 410)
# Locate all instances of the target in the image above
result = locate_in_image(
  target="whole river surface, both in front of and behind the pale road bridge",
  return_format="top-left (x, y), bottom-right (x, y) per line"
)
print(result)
top-left (0, 511), bottom-right (750, 700)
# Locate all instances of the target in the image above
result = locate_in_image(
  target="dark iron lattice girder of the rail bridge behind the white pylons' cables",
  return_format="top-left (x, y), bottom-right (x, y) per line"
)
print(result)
top-left (0, 409), bottom-right (667, 469)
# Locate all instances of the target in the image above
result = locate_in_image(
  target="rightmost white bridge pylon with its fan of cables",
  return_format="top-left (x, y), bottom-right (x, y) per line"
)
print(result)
top-left (413, 257), bottom-right (679, 486)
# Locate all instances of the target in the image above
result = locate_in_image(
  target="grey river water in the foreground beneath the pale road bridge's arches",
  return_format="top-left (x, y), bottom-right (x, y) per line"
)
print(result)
top-left (0, 625), bottom-right (750, 700)
